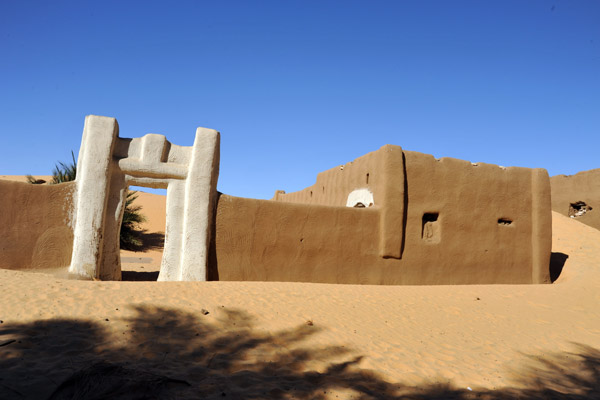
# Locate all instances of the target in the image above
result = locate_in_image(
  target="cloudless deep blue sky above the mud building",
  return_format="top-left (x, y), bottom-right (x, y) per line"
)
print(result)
top-left (0, 0), bottom-right (600, 198)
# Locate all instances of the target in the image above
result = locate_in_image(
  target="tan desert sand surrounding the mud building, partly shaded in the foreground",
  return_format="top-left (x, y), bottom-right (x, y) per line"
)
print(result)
top-left (0, 183), bottom-right (600, 399)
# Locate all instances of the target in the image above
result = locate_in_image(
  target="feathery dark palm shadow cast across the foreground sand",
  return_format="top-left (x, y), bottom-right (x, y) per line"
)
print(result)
top-left (0, 306), bottom-right (600, 400)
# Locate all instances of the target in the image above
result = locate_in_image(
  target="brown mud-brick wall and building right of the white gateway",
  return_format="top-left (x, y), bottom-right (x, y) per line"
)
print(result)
top-left (209, 146), bottom-right (551, 285)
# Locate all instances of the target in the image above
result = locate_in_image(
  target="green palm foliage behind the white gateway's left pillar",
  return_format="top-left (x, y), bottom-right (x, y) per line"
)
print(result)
top-left (27, 150), bottom-right (146, 251)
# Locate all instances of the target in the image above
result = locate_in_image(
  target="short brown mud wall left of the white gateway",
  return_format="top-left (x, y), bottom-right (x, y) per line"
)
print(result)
top-left (0, 180), bottom-right (75, 269)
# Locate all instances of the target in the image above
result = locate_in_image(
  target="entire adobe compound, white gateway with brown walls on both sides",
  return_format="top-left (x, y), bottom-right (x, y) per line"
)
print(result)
top-left (0, 116), bottom-right (552, 285)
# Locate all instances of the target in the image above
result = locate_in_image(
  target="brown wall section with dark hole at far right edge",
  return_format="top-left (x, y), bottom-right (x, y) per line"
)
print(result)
top-left (550, 168), bottom-right (600, 229)
